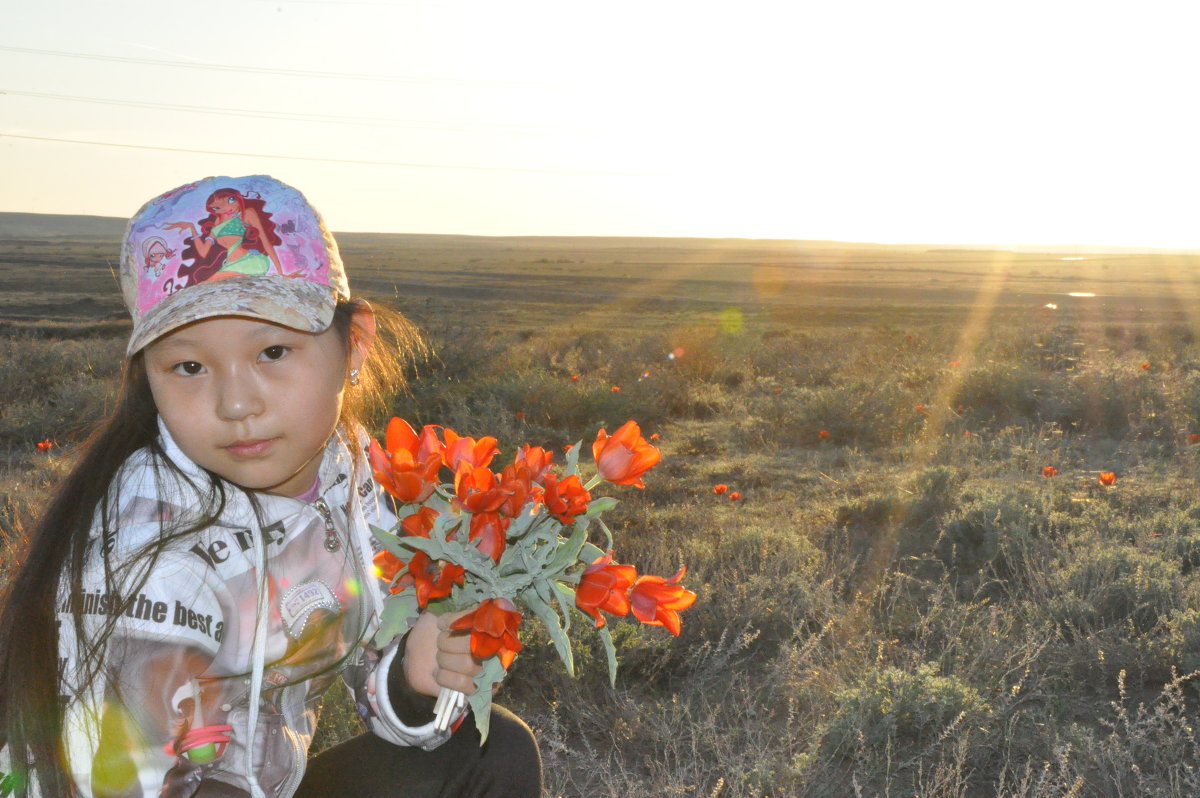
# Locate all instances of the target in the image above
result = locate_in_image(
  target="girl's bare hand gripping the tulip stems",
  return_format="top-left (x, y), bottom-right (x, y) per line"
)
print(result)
top-left (403, 610), bottom-right (484, 696)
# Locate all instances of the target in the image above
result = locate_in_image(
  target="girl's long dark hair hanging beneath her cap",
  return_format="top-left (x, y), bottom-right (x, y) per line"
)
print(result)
top-left (0, 300), bottom-right (427, 798)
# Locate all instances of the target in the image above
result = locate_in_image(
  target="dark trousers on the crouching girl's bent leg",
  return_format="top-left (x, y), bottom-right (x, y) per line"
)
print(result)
top-left (296, 704), bottom-right (542, 798)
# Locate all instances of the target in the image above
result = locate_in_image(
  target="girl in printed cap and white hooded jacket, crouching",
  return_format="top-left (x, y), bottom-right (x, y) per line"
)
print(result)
top-left (0, 176), bottom-right (541, 798)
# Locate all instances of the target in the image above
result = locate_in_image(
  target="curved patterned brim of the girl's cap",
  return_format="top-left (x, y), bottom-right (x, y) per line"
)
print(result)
top-left (125, 275), bottom-right (337, 355)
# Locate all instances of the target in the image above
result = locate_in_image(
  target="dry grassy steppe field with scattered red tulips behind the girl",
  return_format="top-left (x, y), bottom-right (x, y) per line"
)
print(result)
top-left (7, 215), bottom-right (1200, 798)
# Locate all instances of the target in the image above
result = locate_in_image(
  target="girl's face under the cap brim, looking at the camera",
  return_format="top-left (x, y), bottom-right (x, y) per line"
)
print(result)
top-left (145, 317), bottom-right (364, 496)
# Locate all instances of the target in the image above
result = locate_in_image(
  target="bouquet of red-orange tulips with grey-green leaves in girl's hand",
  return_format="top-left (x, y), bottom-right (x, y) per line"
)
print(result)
top-left (368, 418), bottom-right (696, 739)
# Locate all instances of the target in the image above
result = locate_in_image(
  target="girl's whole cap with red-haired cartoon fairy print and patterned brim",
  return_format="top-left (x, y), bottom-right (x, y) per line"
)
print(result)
top-left (121, 175), bottom-right (349, 354)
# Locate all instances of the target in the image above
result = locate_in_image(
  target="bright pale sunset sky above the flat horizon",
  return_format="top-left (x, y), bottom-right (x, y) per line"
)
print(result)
top-left (0, 0), bottom-right (1200, 247)
